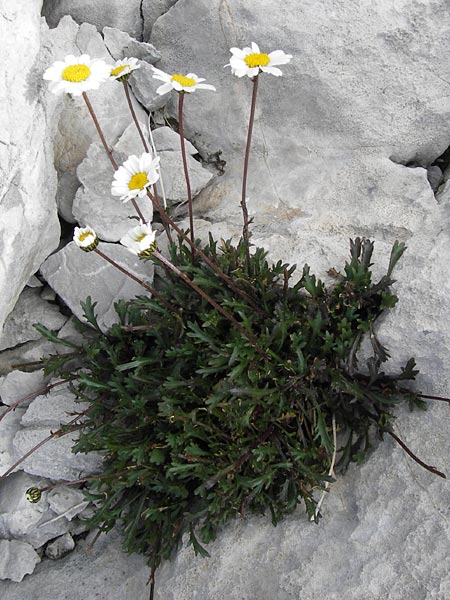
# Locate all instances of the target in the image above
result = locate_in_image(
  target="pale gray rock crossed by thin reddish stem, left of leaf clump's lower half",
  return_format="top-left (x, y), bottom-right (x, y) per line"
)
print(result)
top-left (13, 427), bottom-right (102, 482)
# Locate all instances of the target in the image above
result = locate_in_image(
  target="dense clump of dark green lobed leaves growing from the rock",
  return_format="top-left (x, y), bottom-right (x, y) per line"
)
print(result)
top-left (42, 238), bottom-right (423, 566)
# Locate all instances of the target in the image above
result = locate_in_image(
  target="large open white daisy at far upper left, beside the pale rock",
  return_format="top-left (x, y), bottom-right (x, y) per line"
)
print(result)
top-left (43, 54), bottom-right (111, 96)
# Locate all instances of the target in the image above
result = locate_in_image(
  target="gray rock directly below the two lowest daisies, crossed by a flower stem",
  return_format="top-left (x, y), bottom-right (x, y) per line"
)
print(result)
top-left (41, 242), bottom-right (153, 330)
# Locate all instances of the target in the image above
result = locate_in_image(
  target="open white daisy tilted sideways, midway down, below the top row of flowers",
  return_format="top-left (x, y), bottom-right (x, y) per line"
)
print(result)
top-left (111, 152), bottom-right (159, 202)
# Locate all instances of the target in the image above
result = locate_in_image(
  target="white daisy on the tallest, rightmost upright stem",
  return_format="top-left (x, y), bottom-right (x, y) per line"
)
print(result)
top-left (225, 42), bottom-right (292, 77)
